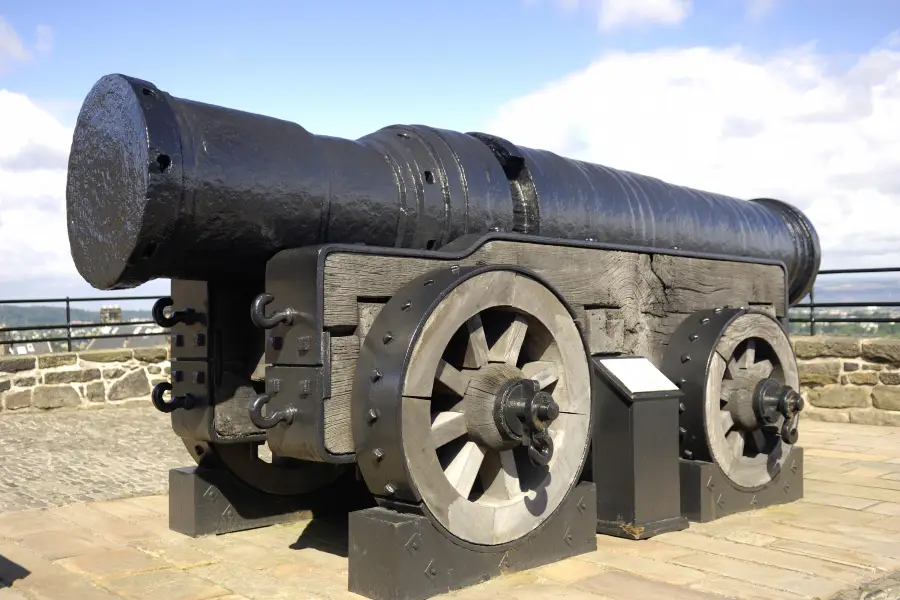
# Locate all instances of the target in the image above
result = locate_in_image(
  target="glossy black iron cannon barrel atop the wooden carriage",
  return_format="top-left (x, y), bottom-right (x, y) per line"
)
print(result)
top-left (66, 75), bottom-right (821, 304)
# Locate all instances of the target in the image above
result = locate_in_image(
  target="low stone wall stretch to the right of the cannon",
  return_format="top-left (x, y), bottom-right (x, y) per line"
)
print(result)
top-left (793, 336), bottom-right (900, 426)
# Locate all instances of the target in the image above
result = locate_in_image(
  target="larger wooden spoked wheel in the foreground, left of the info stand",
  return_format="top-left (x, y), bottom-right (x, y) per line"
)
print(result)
top-left (401, 270), bottom-right (591, 545)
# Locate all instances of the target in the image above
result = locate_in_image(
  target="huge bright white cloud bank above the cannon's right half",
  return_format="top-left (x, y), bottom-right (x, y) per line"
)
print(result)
top-left (486, 36), bottom-right (900, 268)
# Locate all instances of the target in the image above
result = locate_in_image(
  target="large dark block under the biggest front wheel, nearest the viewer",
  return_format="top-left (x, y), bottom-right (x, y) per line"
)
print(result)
top-left (348, 482), bottom-right (597, 600)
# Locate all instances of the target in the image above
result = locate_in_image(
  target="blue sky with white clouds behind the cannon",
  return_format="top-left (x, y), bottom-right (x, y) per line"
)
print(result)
top-left (0, 0), bottom-right (900, 308)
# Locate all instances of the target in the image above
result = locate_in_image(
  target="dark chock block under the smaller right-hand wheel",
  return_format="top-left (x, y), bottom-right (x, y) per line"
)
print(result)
top-left (681, 446), bottom-right (803, 523)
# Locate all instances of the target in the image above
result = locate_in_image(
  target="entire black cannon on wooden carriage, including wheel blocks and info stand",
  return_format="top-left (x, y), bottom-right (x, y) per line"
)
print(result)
top-left (67, 75), bottom-right (820, 598)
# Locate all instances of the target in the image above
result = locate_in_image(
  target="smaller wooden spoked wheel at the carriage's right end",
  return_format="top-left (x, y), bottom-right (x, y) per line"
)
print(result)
top-left (703, 313), bottom-right (800, 488)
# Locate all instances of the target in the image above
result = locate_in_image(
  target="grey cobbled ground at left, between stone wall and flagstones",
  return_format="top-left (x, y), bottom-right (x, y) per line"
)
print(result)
top-left (0, 408), bottom-right (194, 512)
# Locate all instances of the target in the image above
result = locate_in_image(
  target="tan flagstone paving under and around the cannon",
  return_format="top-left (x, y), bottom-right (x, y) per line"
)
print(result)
top-left (0, 419), bottom-right (900, 600)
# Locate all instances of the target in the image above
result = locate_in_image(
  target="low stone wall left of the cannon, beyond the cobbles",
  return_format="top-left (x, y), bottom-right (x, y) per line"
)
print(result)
top-left (0, 346), bottom-right (169, 413)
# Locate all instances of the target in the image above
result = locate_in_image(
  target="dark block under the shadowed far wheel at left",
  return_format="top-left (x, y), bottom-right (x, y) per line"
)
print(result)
top-left (169, 467), bottom-right (312, 537)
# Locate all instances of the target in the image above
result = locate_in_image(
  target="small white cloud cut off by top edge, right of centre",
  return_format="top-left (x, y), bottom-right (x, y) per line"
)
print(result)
top-left (557, 0), bottom-right (691, 31)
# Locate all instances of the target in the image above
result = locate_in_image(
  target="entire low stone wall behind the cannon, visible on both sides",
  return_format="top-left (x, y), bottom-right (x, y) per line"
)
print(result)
top-left (0, 336), bottom-right (900, 426)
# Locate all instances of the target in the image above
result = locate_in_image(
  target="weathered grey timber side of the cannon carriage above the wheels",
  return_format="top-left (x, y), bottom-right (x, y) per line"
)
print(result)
top-left (324, 241), bottom-right (786, 453)
